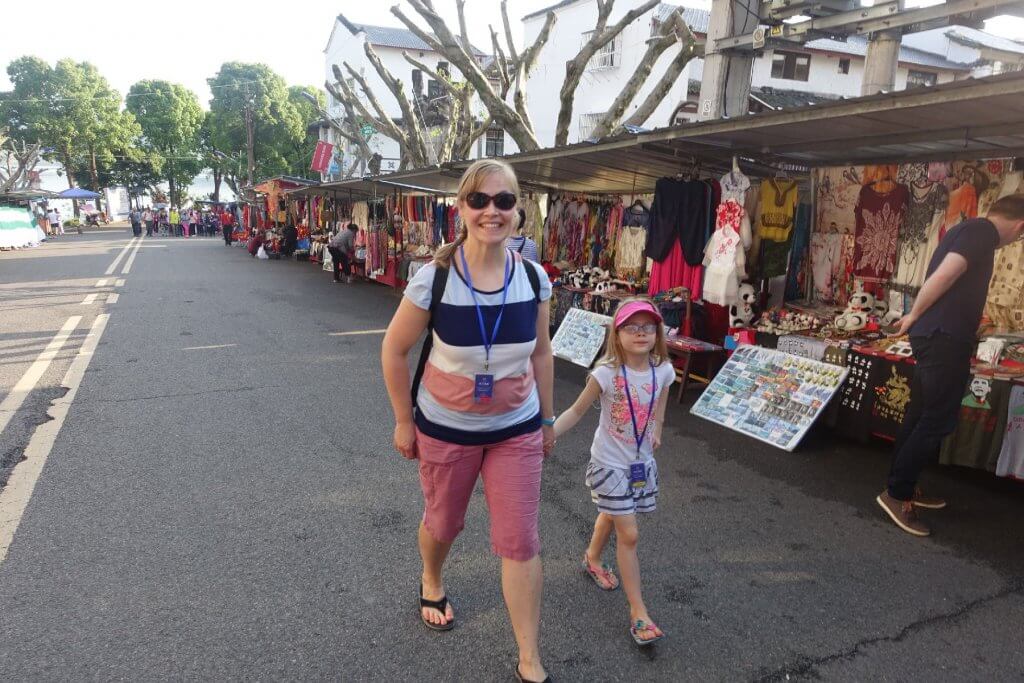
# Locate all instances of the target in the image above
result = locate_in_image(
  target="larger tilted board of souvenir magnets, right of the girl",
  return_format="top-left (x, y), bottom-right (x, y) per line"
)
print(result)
top-left (690, 346), bottom-right (848, 451)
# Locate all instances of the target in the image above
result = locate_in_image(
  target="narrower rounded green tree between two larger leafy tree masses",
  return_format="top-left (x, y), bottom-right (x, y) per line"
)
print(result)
top-left (127, 81), bottom-right (203, 205)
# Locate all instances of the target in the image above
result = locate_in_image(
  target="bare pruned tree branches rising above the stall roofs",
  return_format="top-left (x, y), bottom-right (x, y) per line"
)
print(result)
top-left (327, 0), bottom-right (696, 166)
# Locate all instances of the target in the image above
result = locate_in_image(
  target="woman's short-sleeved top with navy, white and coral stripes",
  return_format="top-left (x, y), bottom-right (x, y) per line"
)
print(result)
top-left (406, 254), bottom-right (551, 445)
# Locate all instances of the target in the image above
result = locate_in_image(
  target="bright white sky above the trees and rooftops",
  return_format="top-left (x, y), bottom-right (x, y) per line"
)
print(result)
top-left (0, 0), bottom-right (1024, 109)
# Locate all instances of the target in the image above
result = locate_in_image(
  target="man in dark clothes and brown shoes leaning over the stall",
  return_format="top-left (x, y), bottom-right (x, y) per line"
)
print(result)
top-left (877, 195), bottom-right (1024, 536)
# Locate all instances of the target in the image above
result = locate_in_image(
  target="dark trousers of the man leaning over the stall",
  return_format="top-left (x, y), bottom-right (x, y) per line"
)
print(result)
top-left (889, 332), bottom-right (974, 501)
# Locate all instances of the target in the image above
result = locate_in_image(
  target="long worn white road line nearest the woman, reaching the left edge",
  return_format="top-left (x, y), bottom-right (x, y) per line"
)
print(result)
top-left (0, 313), bottom-right (111, 564)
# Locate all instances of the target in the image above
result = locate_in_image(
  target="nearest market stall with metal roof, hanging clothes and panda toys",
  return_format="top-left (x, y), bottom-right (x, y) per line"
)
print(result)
top-left (374, 74), bottom-right (1024, 469)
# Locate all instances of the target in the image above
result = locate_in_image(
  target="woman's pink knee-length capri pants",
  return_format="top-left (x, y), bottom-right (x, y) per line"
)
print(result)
top-left (416, 430), bottom-right (544, 561)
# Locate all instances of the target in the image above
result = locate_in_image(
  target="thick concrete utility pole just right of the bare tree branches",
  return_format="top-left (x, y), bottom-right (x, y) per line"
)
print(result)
top-left (697, 0), bottom-right (761, 121)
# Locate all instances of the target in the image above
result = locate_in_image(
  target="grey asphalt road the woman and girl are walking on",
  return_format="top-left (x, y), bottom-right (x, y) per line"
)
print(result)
top-left (0, 231), bottom-right (1024, 681)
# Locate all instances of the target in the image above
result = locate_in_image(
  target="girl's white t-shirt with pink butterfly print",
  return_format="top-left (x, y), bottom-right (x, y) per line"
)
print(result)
top-left (590, 362), bottom-right (676, 469)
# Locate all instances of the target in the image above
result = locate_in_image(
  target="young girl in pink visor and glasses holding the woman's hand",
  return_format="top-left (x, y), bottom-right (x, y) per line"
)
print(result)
top-left (555, 297), bottom-right (675, 646)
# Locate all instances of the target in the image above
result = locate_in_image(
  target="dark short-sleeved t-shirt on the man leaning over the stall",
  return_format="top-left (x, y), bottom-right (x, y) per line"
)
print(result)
top-left (910, 218), bottom-right (999, 342)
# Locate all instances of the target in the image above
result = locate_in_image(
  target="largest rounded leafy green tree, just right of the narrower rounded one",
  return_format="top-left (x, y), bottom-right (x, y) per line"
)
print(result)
top-left (207, 61), bottom-right (305, 183)
